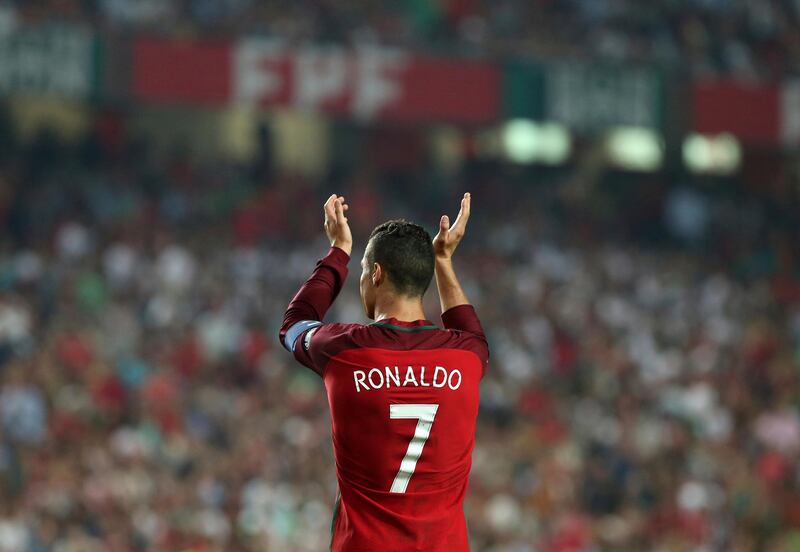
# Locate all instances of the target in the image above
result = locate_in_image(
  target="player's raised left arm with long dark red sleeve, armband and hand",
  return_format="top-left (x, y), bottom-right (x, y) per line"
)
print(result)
top-left (280, 194), bottom-right (353, 366)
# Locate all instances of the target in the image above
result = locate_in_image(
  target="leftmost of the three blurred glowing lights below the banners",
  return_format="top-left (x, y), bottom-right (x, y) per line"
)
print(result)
top-left (502, 119), bottom-right (572, 165)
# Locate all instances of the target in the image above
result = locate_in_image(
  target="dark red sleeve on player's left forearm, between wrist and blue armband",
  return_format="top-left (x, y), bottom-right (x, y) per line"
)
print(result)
top-left (280, 247), bottom-right (350, 342)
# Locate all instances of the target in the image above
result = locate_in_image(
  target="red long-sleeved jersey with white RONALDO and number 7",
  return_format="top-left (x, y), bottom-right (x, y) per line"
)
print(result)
top-left (281, 248), bottom-right (489, 552)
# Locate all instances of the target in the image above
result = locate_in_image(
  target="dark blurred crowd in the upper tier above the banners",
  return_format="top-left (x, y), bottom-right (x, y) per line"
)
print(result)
top-left (0, 0), bottom-right (800, 79)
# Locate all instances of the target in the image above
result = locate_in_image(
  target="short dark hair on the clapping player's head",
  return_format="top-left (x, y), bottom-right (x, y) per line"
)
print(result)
top-left (366, 219), bottom-right (434, 297)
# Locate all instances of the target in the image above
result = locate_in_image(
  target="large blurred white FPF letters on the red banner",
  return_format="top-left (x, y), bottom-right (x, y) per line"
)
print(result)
top-left (233, 39), bottom-right (408, 119)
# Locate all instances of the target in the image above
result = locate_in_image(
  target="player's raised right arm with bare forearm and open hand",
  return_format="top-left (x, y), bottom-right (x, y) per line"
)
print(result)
top-left (433, 194), bottom-right (486, 342)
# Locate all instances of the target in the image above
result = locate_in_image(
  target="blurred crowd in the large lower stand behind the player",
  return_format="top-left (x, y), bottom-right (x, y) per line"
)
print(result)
top-left (0, 110), bottom-right (800, 552)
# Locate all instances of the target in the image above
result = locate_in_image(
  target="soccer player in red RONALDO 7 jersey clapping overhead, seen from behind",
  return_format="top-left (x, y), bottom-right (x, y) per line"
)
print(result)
top-left (280, 194), bottom-right (489, 552)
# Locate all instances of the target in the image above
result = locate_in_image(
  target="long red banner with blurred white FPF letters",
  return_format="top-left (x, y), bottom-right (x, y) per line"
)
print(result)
top-left (133, 39), bottom-right (501, 123)
